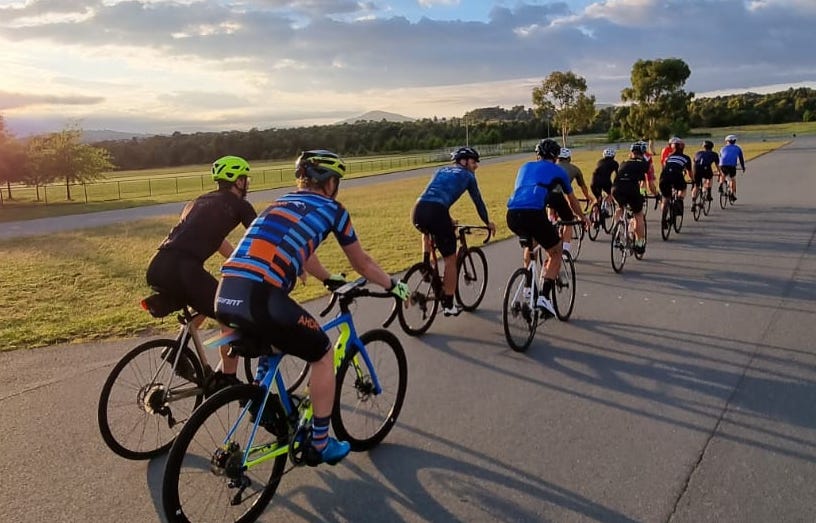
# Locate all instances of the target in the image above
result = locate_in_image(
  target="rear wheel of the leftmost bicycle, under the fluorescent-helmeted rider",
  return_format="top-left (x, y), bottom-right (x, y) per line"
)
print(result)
top-left (97, 339), bottom-right (204, 459)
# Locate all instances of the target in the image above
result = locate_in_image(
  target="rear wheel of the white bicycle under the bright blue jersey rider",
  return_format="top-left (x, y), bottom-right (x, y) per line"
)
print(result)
top-left (502, 267), bottom-right (538, 352)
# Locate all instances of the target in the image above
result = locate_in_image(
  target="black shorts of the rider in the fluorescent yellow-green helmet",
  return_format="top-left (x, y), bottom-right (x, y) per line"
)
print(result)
top-left (146, 249), bottom-right (218, 318)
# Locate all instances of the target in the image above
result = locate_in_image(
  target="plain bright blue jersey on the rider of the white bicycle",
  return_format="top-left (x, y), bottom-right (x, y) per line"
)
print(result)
top-left (507, 160), bottom-right (572, 210)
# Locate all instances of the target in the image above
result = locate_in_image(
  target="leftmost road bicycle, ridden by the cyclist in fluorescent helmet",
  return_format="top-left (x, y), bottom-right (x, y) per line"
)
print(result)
top-left (97, 289), bottom-right (268, 460)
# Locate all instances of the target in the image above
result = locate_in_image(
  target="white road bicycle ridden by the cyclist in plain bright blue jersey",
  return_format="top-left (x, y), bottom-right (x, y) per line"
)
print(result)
top-left (502, 220), bottom-right (581, 352)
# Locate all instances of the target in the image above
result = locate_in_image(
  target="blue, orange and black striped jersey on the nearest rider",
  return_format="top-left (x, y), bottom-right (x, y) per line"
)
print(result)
top-left (221, 191), bottom-right (357, 292)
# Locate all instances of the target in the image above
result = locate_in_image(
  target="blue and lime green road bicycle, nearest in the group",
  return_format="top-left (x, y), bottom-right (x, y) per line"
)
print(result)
top-left (162, 279), bottom-right (408, 522)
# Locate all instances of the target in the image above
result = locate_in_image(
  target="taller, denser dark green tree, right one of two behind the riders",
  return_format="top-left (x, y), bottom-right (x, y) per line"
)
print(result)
top-left (621, 58), bottom-right (694, 138)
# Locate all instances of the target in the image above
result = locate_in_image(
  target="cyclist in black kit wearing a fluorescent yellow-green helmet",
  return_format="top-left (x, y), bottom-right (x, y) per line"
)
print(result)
top-left (146, 156), bottom-right (256, 394)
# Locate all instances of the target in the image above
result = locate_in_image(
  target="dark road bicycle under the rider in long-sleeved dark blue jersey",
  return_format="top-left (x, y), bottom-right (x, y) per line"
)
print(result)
top-left (383, 225), bottom-right (492, 336)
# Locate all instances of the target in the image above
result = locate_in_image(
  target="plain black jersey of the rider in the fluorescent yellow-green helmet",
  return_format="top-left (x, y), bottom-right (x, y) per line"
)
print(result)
top-left (159, 190), bottom-right (255, 264)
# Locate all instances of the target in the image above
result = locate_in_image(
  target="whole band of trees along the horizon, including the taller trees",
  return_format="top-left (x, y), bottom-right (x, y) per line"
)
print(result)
top-left (0, 58), bottom-right (816, 204)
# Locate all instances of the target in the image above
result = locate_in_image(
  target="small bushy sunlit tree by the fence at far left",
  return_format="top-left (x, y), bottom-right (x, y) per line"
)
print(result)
top-left (27, 128), bottom-right (114, 200)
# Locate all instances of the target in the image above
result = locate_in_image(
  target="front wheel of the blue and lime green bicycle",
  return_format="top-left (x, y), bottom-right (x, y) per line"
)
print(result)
top-left (332, 329), bottom-right (408, 452)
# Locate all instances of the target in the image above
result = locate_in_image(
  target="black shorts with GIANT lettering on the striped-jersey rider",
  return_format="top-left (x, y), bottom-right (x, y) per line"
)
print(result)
top-left (215, 276), bottom-right (330, 362)
